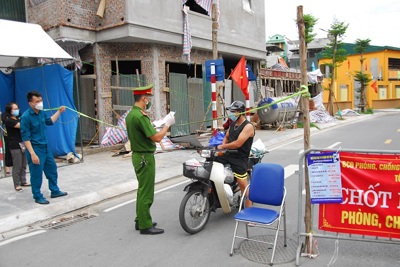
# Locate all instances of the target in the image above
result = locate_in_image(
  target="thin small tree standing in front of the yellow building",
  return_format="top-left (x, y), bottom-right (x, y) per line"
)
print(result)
top-left (354, 39), bottom-right (372, 112)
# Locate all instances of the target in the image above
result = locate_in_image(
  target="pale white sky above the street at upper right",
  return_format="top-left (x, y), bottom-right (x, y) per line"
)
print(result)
top-left (265, 0), bottom-right (400, 48)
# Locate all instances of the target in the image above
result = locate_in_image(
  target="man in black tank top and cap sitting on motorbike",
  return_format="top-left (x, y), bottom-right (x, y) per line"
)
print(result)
top-left (217, 101), bottom-right (255, 207)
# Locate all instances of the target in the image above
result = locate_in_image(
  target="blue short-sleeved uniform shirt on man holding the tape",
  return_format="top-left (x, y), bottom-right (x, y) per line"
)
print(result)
top-left (20, 108), bottom-right (53, 145)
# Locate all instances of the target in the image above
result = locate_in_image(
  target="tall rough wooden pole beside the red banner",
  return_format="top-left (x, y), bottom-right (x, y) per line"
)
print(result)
top-left (297, 6), bottom-right (312, 253)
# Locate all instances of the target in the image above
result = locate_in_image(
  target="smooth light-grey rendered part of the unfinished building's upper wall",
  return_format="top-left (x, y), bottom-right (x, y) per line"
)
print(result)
top-left (112, 0), bottom-right (265, 60)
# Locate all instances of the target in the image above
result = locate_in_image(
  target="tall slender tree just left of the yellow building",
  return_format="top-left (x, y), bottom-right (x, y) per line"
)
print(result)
top-left (321, 19), bottom-right (349, 116)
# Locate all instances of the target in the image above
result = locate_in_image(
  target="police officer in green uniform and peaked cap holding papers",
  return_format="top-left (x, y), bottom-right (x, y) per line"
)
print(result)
top-left (125, 84), bottom-right (175, 235)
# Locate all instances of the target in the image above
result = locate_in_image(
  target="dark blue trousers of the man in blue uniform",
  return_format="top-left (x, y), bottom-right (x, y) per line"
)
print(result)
top-left (26, 146), bottom-right (60, 199)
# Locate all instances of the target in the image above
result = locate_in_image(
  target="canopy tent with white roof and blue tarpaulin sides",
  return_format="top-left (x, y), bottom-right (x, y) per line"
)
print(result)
top-left (0, 20), bottom-right (78, 161)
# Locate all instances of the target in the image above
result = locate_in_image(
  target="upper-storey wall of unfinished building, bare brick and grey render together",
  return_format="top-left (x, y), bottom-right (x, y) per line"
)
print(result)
top-left (26, 0), bottom-right (266, 60)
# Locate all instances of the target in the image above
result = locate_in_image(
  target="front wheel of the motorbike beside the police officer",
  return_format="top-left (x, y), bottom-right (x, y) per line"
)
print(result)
top-left (179, 190), bottom-right (210, 234)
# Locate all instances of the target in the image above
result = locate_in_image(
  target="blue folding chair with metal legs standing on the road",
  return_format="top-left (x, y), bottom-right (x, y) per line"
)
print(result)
top-left (230, 163), bottom-right (286, 266)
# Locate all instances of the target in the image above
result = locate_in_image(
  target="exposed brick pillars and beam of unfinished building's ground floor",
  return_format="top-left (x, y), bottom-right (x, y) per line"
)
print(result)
top-left (81, 43), bottom-right (212, 123)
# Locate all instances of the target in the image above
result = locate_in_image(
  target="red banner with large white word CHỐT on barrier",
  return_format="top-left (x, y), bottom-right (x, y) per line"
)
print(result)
top-left (318, 152), bottom-right (400, 238)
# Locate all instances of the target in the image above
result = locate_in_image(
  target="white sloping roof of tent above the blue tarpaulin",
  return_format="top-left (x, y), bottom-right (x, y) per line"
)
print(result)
top-left (0, 19), bottom-right (73, 68)
